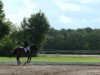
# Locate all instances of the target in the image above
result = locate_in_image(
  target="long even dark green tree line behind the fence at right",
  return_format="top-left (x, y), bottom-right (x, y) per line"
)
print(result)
top-left (45, 27), bottom-right (100, 50)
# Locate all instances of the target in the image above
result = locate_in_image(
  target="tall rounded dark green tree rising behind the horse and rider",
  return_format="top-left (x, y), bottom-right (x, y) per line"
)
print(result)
top-left (21, 11), bottom-right (50, 55)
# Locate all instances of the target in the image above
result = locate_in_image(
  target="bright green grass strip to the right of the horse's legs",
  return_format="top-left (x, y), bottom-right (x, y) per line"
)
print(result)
top-left (32, 57), bottom-right (100, 62)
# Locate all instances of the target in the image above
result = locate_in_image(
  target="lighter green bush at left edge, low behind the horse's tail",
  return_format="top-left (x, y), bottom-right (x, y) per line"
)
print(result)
top-left (0, 36), bottom-right (17, 56)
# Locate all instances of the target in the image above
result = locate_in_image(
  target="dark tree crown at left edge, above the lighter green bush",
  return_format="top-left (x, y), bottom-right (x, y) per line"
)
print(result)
top-left (0, 1), bottom-right (10, 39)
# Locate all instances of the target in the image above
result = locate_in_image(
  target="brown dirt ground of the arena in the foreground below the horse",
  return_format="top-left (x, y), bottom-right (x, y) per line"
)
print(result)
top-left (0, 64), bottom-right (100, 75)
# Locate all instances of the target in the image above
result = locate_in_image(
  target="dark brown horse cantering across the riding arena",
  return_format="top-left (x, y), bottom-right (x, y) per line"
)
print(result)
top-left (12, 45), bottom-right (37, 65)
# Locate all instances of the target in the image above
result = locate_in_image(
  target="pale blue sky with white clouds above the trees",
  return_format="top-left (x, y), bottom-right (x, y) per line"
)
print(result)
top-left (2, 0), bottom-right (100, 29)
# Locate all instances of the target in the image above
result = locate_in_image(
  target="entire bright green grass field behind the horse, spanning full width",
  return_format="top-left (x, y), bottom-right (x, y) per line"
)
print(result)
top-left (0, 55), bottom-right (100, 62)
